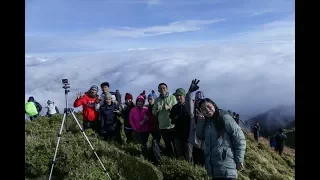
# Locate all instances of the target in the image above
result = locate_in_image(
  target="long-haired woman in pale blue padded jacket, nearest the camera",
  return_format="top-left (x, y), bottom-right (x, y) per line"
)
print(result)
top-left (196, 98), bottom-right (246, 179)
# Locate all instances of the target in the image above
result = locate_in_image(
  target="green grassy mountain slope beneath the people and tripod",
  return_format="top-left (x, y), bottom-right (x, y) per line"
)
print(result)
top-left (25, 114), bottom-right (295, 180)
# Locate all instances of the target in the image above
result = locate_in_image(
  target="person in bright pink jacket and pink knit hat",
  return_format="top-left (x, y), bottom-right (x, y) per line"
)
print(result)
top-left (129, 95), bottom-right (151, 155)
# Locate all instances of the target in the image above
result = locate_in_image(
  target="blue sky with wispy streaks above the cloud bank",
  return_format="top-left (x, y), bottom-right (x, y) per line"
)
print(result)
top-left (25, 0), bottom-right (295, 54)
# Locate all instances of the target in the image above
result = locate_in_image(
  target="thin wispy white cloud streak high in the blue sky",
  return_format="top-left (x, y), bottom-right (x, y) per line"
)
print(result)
top-left (91, 19), bottom-right (225, 38)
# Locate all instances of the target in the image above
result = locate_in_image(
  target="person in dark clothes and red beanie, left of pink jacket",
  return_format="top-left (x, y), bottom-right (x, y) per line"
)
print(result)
top-left (121, 93), bottom-right (135, 143)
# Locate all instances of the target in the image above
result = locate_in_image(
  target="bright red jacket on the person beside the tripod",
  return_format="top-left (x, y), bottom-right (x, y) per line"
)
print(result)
top-left (73, 93), bottom-right (99, 121)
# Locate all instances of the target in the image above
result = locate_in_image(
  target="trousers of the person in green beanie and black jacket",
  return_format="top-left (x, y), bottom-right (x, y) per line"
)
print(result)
top-left (174, 138), bottom-right (193, 163)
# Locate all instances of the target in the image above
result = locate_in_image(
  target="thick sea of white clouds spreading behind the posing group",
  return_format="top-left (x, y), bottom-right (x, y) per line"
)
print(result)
top-left (25, 21), bottom-right (295, 119)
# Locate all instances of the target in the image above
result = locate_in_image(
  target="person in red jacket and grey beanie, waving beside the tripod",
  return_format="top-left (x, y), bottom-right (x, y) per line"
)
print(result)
top-left (73, 85), bottom-right (99, 131)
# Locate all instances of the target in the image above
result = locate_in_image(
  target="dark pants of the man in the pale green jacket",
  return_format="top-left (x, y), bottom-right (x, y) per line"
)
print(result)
top-left (160, 128), bottom-right (176, 157)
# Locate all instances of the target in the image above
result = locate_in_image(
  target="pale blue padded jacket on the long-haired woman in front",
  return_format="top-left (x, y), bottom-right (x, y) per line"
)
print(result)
top-left (196, 110), bottom-right (246, 178)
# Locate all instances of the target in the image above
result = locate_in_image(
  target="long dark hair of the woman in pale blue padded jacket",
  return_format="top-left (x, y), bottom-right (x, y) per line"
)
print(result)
top-left (199, 98), bottom-right (224, 138)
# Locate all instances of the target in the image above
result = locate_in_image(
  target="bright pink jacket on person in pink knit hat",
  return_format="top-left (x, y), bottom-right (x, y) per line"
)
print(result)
top-left (129, 106), bottom-right (151, 132)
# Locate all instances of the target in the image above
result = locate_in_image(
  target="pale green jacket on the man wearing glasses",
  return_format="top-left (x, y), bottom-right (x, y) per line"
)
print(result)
top-left (152, 94), bottom-right (177, 129)
